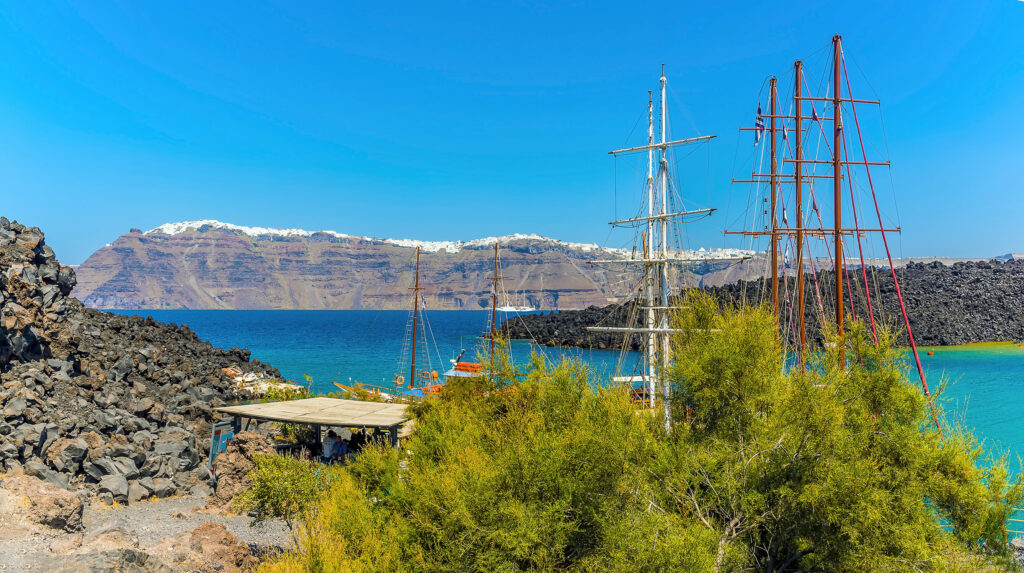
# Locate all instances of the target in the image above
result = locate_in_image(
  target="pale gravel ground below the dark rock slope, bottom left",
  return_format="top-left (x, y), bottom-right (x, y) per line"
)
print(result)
top-left (0, 496), bottom-right (292, 572)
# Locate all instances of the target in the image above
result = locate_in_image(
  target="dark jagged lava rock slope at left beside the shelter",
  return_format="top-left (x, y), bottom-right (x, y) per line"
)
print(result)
top-left (0, 218), bottom-right (280, 502)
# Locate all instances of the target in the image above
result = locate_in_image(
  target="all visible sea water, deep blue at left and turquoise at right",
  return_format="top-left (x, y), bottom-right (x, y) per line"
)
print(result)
top-left (110, 310), bottom-right (1024, 462)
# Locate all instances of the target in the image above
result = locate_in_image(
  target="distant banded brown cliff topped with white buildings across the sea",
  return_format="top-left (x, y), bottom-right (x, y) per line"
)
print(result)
top-left (68, 221), bottom-right (749, 309)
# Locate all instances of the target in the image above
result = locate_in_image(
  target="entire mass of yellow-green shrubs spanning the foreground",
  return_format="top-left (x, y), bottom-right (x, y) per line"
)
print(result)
top-left (258, 297), bottom-right (1022, 571)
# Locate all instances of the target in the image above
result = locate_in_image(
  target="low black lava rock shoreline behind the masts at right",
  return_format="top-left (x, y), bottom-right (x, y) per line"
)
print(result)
top-left (502, 260), bottom-right (1024, 350)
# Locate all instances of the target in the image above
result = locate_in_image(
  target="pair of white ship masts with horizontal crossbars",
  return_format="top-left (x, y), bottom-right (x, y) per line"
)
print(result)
top-left (588, 64), bottom-right (745, 430)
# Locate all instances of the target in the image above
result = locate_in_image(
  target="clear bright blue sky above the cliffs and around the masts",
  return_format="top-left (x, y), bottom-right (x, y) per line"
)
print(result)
top-left (0, 0), bottom-right (1024, 263)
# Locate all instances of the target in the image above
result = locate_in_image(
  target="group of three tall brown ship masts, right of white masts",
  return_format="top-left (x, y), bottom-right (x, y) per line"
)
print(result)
top-left (726, 35), bottom-right (941, 433)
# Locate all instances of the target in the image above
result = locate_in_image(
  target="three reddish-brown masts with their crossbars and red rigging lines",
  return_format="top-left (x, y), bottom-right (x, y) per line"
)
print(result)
top-left (726, 35), bottom-right (942, 434)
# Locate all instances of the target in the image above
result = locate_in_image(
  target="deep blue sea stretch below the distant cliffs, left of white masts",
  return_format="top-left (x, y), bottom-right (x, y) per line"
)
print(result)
top-left (114, 310), bottom-right (639, 392)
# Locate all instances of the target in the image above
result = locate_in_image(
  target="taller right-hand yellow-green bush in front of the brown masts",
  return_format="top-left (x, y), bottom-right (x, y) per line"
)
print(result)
top-left (655, 296), bottom-right (1022, 571)
